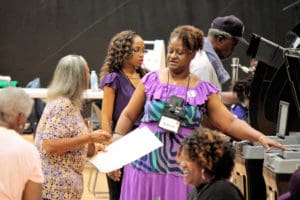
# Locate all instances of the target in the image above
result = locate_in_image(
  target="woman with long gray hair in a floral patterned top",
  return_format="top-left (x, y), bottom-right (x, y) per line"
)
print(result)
top-left (35, 55), bottom-right (111, 200)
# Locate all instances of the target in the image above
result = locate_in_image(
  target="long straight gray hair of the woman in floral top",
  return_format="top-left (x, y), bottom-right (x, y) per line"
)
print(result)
top-left (48, 55), bottom-right (88, 109)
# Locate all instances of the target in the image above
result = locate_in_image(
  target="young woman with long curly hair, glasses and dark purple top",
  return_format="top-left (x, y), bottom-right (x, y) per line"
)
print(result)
top-left (100, 30), bottom-right (146, 200)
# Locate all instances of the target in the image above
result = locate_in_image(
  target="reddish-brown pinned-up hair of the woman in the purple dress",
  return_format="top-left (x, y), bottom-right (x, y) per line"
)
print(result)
top-left (170, 25), bottom-right (204, 52)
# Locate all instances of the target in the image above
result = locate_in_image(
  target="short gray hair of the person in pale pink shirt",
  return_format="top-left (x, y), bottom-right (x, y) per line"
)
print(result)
top-left (0, 87), bottom-right (33, 124)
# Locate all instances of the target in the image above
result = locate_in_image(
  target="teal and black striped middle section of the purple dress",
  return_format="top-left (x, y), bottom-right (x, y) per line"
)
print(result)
top-left (131, 100), bottom-right (206, 175)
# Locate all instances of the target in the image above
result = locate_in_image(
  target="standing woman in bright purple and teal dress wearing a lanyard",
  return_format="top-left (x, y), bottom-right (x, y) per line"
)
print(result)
top-left (111, 25), bottom-right (282, 200)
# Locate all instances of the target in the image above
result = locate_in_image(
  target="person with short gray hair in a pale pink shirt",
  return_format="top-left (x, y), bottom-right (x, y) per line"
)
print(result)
top-left (0, 88), bottom-right (44, 200)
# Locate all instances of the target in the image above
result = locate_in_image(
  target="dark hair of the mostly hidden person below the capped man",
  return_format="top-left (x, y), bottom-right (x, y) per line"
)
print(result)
top-left (232, 75), bottom-right (253, 102)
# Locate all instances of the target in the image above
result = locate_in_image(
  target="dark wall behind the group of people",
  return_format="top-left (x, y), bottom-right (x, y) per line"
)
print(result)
top-left (0, 0), bottom-right (300, 89)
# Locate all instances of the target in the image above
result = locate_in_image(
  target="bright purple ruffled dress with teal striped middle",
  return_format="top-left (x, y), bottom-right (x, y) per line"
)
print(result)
top-left (120, 71), bottom-right (218, 200)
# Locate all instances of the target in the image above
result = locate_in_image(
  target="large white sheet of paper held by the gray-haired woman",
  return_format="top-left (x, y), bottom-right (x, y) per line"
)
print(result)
top-left (90, 127), bottom-right (163, 173)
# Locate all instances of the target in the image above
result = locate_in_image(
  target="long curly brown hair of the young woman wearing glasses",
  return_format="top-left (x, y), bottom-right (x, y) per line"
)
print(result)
top-left (100, 30), bottom-right (146, 80)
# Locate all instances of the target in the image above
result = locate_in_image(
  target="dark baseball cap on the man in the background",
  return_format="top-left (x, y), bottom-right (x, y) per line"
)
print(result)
top-left (210, 15), bottom-right (249, 45)
